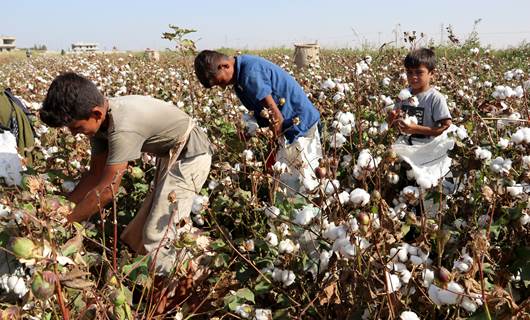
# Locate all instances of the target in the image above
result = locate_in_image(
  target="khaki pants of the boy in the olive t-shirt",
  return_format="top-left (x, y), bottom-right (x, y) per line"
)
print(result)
top-left (121, 154), bottom-right (212, 275)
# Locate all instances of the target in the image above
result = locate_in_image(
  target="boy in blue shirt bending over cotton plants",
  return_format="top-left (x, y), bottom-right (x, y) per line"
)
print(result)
top-left (195, 50), bottom-right (322, 195)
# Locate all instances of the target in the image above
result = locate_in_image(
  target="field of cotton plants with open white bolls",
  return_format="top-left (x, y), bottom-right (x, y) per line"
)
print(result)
top-left (0, 46), bottom-right (530, 320)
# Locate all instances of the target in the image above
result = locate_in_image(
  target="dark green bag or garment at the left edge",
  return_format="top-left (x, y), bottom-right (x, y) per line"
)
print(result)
top-left (0, 89), bottom-right (35, 165)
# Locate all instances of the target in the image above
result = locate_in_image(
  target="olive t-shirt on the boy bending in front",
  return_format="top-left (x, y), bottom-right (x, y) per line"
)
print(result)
top-left (90, 96), bottom-right (212, 164)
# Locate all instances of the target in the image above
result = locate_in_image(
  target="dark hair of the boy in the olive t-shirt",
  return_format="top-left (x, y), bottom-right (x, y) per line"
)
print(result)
top-left (39, 72), bottom-right (105, 127)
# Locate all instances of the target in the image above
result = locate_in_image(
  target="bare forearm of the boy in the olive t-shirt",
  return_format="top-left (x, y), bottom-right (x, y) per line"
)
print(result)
top-left (66, 162), bottom-right (127, 222)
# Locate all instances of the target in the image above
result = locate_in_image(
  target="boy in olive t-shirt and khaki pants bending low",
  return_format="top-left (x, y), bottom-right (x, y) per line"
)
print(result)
top-left (40, 73), bottom-right (212, 275)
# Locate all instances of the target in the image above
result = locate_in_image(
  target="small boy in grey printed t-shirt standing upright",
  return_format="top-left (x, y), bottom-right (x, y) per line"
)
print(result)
top-left (388, 48), bottom-right (451, 144)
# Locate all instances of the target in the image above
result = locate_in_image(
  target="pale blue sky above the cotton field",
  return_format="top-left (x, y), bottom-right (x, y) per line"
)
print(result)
top-left (0, 0), bottom-right (530, 50)
